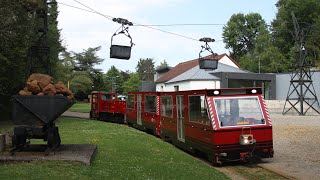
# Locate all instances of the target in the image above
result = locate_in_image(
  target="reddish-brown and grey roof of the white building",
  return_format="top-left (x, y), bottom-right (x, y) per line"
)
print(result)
top-left (155, 53), bottom-right (244, 83)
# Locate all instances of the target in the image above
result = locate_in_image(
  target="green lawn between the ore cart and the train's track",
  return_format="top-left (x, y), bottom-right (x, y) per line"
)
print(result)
top-left (0, 118), bottom-right (228, 179)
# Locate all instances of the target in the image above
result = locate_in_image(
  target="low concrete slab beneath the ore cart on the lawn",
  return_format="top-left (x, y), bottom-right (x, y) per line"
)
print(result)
top-left (0, 144), bottom-right (97, 165)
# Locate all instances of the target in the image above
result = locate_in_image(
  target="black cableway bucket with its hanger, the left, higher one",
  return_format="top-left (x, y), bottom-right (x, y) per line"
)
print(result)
top-left (110, 18), bottom-right (133, 60)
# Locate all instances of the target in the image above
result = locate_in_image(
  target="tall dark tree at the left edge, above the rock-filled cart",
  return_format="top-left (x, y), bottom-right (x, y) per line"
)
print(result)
top-left (0, 0), bottom-right (37, 96)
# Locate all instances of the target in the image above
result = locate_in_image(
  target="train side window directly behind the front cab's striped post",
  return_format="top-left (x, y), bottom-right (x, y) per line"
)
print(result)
top-left (188, 95), bottom-right (210, 125)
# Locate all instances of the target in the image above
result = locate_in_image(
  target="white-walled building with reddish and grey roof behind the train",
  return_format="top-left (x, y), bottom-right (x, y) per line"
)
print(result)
top-left (155, 54), bottom-right (276, 99)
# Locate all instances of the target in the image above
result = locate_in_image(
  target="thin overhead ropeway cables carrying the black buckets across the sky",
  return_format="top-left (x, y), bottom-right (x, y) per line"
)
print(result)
top-left (59, 0), bottom-right (220, 42)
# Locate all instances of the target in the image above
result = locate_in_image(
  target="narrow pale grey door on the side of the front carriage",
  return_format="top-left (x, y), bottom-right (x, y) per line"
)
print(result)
top-left (176, 95), bottom-right (185, 142)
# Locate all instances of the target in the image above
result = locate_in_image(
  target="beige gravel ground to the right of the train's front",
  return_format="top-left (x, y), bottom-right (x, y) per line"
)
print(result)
top-left (260, 114), bottom-right (320, 179)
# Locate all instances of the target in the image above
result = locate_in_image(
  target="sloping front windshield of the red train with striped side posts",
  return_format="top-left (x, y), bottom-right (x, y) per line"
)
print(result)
top-left (214, 97), bottom-right (265, 127)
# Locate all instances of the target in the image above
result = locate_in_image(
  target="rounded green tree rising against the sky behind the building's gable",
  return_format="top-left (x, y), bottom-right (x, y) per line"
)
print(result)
top-left (222, 13), bottom-right (267, 61)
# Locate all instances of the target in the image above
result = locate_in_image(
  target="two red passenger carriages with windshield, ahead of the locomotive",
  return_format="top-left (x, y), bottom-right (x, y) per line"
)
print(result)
top-left (89, 88), bottom-right (273, 164)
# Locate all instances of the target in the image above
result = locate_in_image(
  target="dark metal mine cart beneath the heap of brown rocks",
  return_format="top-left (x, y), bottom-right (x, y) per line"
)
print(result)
top-left (12, 95), bottom-right (74, 152)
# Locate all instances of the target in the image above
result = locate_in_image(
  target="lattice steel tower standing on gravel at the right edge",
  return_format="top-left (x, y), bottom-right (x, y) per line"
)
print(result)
top-left (282, 13), bottom-right (320, 116)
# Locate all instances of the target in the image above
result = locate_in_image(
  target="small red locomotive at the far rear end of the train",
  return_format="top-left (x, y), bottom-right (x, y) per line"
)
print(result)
top-left (90, 91), bottom-right (126, 123)
